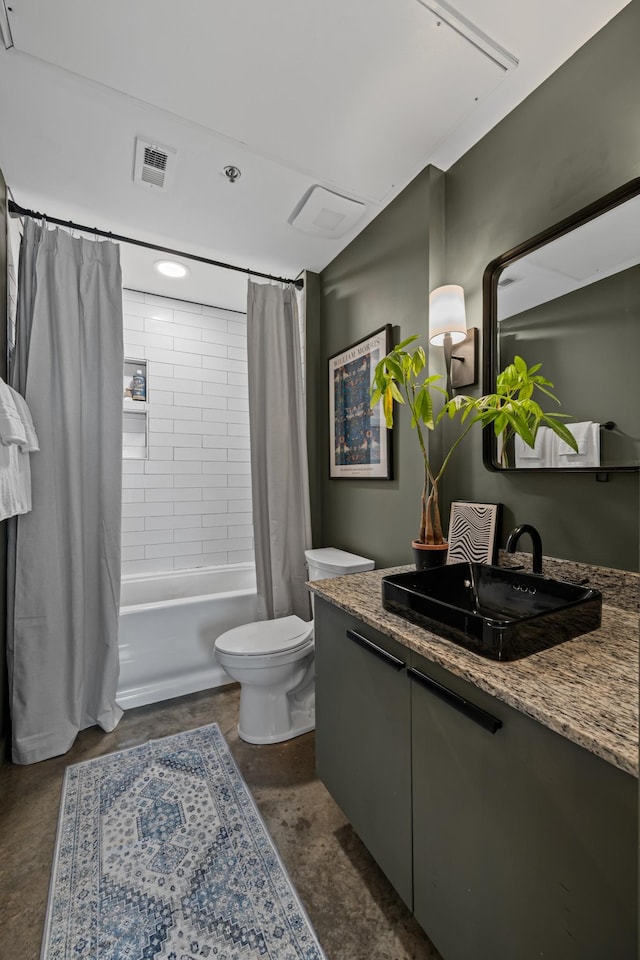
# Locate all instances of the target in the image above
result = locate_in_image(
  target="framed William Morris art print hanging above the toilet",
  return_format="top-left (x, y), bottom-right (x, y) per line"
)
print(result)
top-left (329, 323), bottom-right (392, 480)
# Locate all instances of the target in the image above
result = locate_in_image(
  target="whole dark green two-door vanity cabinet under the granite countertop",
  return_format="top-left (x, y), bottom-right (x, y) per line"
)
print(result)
top-left (315, 597), bottom-right (638, 960)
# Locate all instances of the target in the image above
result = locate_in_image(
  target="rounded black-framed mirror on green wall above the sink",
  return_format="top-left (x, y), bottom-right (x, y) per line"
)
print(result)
top-left (483, 177), bottom-right (640, 473)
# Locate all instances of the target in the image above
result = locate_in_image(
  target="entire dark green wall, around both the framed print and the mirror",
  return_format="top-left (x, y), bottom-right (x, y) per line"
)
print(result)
top-left (315, 0), bottom-right (640, 569)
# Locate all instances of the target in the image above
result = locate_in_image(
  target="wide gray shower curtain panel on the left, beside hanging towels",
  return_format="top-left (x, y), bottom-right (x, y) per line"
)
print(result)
top-left (7, 219), bottom-right (123, 763)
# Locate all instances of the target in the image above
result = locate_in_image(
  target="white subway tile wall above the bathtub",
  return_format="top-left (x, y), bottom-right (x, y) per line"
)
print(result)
top-left (122, 290), bottom-right (254, 573)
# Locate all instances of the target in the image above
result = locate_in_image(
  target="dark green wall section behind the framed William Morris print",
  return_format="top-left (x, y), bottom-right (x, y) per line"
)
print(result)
top-left (318, 168), bottom-right (443, 565)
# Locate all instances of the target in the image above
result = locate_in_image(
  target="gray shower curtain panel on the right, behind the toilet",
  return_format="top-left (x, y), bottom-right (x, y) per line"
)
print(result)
top-left (247, 282), bottom-right (311, 620)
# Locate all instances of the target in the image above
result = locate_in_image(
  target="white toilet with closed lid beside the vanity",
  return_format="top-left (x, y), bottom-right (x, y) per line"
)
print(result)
top-left (215, 547), bottom-right (375, 743)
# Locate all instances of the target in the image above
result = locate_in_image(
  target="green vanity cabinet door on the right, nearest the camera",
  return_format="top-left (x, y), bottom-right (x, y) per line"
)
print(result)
top-left (409, 654), bottom-right (637, 960)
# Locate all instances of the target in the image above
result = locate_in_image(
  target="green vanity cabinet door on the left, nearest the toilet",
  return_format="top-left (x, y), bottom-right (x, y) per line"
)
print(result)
top-left (314, 597), bottom-right (412, 907)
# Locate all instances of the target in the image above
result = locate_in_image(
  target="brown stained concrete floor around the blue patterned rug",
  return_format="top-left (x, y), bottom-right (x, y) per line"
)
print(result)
top-left (0, 685), bottom-right (440, 960)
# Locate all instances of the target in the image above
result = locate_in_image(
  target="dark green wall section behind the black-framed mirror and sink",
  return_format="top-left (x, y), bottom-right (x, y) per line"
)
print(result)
top-left (445, 0), bottom-right (640, 569)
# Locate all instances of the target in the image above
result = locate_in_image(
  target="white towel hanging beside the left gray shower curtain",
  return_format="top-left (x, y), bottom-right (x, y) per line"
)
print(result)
top-left (0, 378), bottom-right (40, 520)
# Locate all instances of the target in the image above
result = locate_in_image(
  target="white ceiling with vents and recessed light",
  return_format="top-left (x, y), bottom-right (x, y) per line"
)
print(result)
top-left (0, 0), bottom-right (626, 308)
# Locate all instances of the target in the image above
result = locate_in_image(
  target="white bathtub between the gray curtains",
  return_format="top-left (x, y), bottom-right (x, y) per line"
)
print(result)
top-left (116, 563), bottom-right (257, 710)
